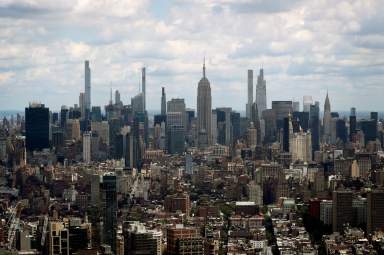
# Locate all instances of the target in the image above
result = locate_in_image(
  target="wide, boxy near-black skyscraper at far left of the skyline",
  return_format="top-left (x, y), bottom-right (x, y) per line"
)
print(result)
top-left (25, 103), bottom-right (49, 151)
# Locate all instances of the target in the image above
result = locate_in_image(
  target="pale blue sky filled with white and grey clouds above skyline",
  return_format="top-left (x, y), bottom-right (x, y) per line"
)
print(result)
top-left (0, 0), bottom-right (384, 111)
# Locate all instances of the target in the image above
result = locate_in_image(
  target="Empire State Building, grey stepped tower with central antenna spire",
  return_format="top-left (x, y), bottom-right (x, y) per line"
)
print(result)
top-left (197, 60), bottom-right (212, 147)
